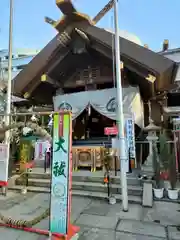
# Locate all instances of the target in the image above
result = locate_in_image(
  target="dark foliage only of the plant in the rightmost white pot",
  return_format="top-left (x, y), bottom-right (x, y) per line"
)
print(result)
top-left (169, 151), bottom-right (177, 190)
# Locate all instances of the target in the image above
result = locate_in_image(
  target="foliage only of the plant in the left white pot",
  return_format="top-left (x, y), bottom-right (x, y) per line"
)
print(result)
top-left (152, 143), bottom-right (161, 188)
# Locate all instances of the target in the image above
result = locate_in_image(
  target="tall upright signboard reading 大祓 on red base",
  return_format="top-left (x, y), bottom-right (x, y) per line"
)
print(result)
top-left (49, 112), bottom-right (79, 239)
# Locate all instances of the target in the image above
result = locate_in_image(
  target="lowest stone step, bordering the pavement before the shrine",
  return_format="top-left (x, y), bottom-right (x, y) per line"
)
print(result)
top-left (9, 185), bottom-right (142, 204)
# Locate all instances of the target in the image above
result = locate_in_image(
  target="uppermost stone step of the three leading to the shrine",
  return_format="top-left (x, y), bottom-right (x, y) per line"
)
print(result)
top-left (26, 172), bottom-right (141, 186)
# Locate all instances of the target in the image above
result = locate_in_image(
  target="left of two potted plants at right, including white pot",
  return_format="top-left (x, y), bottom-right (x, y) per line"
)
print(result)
top-left (152, 142), bottom-right (164, 199)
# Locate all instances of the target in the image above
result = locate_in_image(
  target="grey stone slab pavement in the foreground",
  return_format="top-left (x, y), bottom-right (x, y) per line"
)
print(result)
top-left (0, 192), bottom-right (180, 240)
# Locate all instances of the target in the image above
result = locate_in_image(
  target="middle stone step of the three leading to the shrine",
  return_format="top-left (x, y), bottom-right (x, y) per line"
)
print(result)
top-left (16, 178), bottom-right (142, 196)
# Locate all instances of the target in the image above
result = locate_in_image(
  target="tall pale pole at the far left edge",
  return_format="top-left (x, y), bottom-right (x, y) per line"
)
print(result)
top-left (5, 0), bottom-right (14, 186)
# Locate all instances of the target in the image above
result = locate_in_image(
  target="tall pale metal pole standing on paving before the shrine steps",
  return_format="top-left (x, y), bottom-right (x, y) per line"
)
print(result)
top-left (114, 0), bottom-right (128, 212)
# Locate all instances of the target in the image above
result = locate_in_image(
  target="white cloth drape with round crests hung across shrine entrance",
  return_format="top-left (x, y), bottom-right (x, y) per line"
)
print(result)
top-left (54, 87), bottom-right (144, 128)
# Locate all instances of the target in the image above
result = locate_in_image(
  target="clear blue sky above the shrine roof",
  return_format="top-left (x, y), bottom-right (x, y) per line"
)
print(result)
top-left (0, 0), bottom-right (180, 51)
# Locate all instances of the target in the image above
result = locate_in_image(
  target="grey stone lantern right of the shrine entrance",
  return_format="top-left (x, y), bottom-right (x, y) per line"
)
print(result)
top-left (143, 120), bottom-right (161, 175)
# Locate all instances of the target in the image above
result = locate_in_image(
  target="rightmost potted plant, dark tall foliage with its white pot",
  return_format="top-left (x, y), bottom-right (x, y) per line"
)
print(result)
top-left (167, 151), bottom-right (179, 200)
